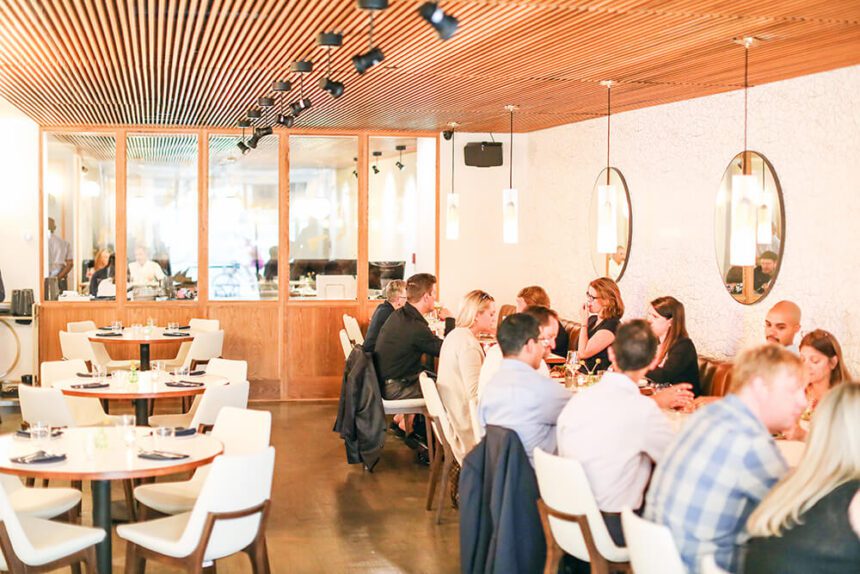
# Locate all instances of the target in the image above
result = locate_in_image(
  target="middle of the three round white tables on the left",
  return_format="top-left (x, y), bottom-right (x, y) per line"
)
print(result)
top-left (54, 371), bottom-right (228, 426)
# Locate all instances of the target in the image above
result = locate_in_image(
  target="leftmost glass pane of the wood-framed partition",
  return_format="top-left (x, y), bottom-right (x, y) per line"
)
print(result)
top-left (43, 133), bottom-right (116, 300)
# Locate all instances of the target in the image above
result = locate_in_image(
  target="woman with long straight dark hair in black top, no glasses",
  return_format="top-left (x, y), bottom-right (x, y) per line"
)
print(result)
top-left (645, 297), bottom-right (702, 396)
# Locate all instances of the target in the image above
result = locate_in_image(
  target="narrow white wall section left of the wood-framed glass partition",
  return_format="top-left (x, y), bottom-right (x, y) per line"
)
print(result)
top-left (0, 98), bottom-right (39, 379)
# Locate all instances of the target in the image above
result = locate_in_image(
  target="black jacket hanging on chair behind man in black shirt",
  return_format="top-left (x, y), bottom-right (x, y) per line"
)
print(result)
top-left (334, 345), bottom-right (385, 471)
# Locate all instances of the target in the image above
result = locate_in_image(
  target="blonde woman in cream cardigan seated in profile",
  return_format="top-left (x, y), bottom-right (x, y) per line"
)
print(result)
top-left (436, 290), bottom-right (496, 460)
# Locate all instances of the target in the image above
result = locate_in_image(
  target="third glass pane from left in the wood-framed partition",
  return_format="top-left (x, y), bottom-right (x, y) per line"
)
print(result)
top-left (209, 136), bottom-right (278, 300)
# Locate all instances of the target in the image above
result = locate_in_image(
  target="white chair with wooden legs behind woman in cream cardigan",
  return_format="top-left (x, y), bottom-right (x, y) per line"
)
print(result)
top-left (418, 373), bottom-right (463, 524)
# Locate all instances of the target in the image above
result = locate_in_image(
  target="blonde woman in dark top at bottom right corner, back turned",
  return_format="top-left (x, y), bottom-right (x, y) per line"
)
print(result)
top-left (743, 383), bottom-right (860, 574)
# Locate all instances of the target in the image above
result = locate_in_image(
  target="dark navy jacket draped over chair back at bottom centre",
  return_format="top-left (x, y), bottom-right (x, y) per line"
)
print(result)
top-left (460, 425), bottom-right (546, 574)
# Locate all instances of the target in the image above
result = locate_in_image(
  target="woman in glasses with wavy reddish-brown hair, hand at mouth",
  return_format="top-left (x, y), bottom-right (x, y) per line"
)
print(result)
top-left (577, 277), bottom-right (624, 372)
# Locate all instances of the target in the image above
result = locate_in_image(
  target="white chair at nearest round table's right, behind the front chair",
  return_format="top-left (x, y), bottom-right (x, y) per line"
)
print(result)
top-left (134, 407), bottom-right (272, 514)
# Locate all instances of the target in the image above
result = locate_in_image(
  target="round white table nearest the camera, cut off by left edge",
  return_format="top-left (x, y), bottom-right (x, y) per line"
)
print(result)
top-left (0, 427), bottom-right (224, 574)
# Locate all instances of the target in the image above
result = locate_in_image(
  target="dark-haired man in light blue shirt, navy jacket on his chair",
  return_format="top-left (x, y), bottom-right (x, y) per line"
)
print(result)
top-left (478, 313), bottom-right (571, 465)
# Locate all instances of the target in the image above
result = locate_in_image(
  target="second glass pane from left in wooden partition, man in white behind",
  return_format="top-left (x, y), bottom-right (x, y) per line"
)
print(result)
top-left (126, 135), bottom-right (197, 301)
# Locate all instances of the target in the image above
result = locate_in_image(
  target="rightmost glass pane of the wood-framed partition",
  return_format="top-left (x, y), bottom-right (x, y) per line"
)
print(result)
top-left (367, 137), bottom-right (436, 299)
